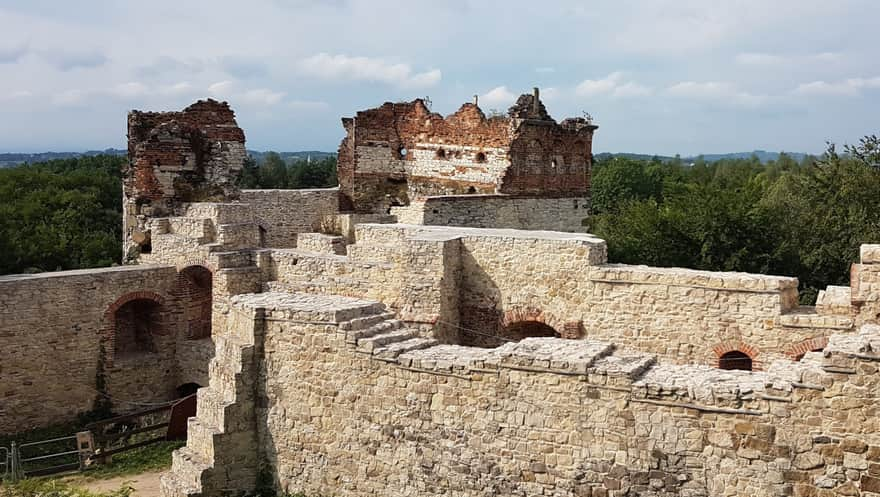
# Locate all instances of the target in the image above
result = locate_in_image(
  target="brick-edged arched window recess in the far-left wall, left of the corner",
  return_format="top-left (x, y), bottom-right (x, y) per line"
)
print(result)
top-left (113, 299), bottom-right (161, 359)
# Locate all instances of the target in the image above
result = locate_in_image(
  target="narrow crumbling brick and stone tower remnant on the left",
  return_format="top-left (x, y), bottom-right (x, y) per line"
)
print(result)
top-left (122, 99), bottom-right (247, 261)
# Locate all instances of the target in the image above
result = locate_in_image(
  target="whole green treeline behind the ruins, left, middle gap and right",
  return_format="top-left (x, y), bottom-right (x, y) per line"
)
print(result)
top-left (0, 136), bottom-right (880, 303)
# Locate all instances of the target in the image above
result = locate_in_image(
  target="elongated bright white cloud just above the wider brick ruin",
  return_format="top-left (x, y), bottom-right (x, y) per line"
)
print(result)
top-left (300, 53), bottom-right (442, 88)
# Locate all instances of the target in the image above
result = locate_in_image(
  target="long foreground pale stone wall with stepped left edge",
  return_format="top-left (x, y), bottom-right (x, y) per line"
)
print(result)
top-left (163, 293), bottom-right (880, 497)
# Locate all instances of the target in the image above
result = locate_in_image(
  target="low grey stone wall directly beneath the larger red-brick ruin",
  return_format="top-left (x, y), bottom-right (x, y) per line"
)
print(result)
top-left (391, 195), bottom-right (590, 232)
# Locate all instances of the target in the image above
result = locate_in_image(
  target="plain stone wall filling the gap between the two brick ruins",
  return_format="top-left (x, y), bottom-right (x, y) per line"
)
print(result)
top-left (241, 188), bottom-right (339, 248)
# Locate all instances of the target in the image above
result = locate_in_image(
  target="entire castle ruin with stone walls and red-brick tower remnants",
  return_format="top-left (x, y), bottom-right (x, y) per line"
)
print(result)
top-left (0, 92), bottom-right (880, 497)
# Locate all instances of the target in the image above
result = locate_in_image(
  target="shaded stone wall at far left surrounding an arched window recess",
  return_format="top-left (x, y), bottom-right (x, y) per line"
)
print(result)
top-left (0, 265), bottom-right (184, 433)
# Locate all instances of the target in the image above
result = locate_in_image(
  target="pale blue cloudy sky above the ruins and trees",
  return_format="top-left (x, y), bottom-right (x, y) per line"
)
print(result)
top-left (0, 0), bottom-right (880, 155)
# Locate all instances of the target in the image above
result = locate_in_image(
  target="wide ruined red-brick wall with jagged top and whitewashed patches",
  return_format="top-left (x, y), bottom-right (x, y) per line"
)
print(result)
top-left (339, 95), bottom-right (596, 221)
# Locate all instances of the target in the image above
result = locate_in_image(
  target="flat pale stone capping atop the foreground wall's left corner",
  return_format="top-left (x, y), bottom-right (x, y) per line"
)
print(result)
top-left (232, 292), bottom-right (385, 323)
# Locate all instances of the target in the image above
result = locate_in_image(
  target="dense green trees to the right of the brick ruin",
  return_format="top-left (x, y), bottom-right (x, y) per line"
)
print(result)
top-left (587, 136), bottom-right (880, 302)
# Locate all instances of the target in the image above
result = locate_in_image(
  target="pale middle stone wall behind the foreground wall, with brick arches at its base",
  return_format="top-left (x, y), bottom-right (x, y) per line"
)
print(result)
top-left (262, 224), bottom-right (860, 369)
